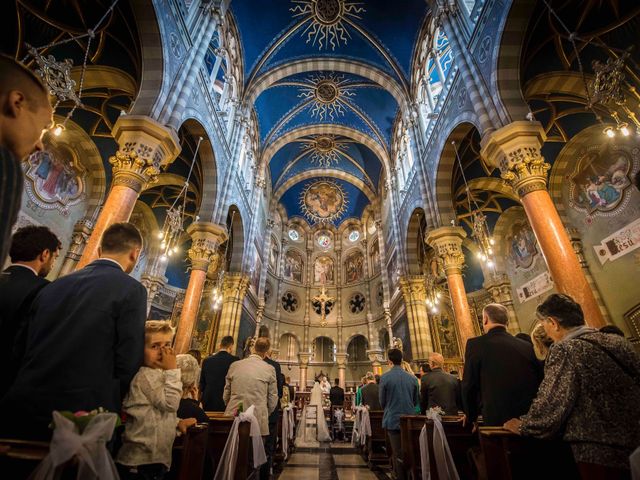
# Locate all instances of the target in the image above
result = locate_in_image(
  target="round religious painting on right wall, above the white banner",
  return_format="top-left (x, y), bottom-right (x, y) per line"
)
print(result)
top-left (569, 147), bottom-right (633, 214)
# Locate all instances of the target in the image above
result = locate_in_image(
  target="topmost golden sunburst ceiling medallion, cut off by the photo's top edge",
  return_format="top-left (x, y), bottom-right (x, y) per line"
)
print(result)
top-left (289, 0), bottom-right (366, 50)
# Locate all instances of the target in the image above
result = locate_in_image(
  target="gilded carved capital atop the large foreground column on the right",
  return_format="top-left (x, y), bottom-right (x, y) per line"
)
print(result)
top-left (480, 121), bottom-right (551, 197)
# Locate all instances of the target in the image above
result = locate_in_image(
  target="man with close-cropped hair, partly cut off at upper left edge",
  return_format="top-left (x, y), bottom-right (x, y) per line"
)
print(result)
top-left (0, 55), bottom-right (53, 268)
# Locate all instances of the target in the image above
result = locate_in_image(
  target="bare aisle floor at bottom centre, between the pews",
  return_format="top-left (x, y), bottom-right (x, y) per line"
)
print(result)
top-left (276, 442), bottom-right (389, 480)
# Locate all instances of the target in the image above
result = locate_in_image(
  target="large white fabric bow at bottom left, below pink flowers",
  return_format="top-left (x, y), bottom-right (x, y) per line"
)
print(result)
top-left (29, 411), bottom-right (120, 480)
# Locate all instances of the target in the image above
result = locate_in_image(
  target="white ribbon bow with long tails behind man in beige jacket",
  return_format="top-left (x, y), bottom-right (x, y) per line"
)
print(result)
top-left (213, 405), bottom-right (267, 480)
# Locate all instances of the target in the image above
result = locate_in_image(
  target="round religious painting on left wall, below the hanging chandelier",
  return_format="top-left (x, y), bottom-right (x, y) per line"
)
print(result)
top-left (25, 146), bottom-right (86, 213)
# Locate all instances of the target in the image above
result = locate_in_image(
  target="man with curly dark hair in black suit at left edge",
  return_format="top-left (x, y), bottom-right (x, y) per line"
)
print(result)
top-left (0, 225), bottom-right (62, 398)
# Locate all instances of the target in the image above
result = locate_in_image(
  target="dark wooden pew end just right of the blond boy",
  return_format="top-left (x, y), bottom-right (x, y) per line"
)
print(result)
top-left (167, 424), bottom-right (209, 480)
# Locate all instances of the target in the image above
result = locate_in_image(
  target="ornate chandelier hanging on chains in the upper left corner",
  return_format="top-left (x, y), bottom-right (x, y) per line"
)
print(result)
top-left (22, 0), bottom-right (118, 137)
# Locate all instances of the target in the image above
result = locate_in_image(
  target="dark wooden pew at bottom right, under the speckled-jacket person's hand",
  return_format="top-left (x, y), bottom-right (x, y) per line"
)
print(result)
top-left (480, 427), bottom-right (580, 480)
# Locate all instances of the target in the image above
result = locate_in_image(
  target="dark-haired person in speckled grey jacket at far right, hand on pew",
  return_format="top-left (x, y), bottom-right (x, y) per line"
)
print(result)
top-left (504, 294), bottom-right (640, 479)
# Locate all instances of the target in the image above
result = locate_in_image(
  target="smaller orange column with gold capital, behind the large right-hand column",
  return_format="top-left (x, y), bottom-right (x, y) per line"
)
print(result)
top-left (425, 227), bottom-right (477, 350)
